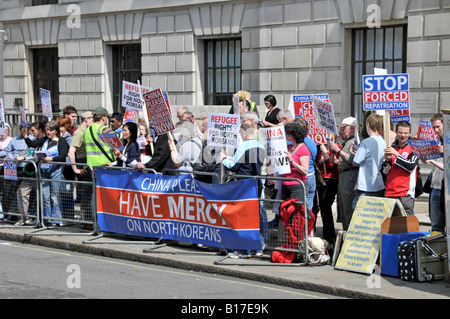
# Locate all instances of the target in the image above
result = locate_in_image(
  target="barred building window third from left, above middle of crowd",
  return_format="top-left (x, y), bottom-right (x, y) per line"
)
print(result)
top-left (205, 39), bottom-right (241, 105)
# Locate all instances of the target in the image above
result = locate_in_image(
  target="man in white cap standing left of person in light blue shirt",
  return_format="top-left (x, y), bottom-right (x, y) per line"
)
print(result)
top-left (330, 116), bottom-right (358, 230)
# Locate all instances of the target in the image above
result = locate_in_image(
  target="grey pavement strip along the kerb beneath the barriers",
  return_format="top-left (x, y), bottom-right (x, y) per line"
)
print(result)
top-left (0, 196), bottom-right (450, 299)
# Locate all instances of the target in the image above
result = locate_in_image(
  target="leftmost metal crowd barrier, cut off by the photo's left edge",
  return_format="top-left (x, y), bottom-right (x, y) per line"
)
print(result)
top-left (0, 161), bottom-right (41, 228)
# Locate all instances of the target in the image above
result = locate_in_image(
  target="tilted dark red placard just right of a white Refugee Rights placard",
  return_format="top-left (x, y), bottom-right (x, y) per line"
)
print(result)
top-left (143, 89), bottom-right (175, 135)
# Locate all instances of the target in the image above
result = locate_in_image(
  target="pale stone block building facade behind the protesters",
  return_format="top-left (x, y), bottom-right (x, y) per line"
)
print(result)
top-left (0, 0), bottom-right (450, 130)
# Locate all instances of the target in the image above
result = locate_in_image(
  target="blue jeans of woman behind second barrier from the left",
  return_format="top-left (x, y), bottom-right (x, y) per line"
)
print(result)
top-left (42, 166), bottom-right (62, 223)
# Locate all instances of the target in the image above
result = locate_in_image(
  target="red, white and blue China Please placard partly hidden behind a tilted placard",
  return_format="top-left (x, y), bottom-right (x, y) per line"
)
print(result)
top-left (289, 93), bottom-right (330, 144)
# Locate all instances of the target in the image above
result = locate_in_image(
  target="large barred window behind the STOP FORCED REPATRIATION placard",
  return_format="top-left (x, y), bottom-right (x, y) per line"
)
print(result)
top-left (352, 25), bottom-right (407, 123)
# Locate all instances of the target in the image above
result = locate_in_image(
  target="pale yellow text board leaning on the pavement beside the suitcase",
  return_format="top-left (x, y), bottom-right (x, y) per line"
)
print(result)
top-left (335, 196), bottom-right (406, 275)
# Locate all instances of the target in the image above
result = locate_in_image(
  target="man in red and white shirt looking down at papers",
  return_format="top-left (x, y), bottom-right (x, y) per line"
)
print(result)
top-left (383, 121), bottom-right (419, 215)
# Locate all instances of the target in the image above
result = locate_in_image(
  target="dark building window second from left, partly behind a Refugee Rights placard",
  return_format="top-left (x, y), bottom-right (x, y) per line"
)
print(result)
top-left (113, 44), bottom-right (142, 113)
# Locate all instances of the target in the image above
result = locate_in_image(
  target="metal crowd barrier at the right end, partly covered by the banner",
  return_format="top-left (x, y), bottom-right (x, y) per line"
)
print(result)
top-left (215, 174), bottom-right (309, 266)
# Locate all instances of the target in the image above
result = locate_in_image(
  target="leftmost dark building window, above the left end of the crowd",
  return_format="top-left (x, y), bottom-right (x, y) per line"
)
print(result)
top-left (33, 48), bottom-right (59, 113)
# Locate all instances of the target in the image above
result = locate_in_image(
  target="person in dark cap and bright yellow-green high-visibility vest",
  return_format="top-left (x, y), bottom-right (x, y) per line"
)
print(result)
top-left (83, 107), bottom-right (115, 167)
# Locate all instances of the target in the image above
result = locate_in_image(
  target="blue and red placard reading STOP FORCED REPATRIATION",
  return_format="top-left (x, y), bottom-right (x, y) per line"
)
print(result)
top-left (363, 74), bottom-right (409, 111)
